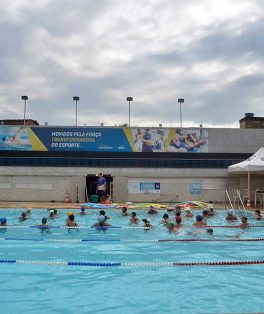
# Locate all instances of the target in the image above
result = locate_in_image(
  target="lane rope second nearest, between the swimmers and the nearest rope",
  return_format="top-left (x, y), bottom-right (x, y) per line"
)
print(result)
top-left (0, 237), bottom-right (264, 243)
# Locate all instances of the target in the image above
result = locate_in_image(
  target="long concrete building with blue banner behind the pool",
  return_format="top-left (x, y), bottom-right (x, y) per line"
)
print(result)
top-left (0, 121), bottom-right (264, 202)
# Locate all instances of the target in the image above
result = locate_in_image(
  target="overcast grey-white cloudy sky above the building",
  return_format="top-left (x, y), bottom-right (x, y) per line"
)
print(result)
top-left (0, 0), bottom-right (264, 127)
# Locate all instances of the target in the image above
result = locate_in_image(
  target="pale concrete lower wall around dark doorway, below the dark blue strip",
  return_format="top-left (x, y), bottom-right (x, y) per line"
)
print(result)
top-left (0, 167), bottom-right (240, 202)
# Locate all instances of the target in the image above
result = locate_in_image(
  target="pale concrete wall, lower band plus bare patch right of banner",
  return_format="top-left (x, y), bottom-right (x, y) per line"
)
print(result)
top-left (0, 129), bottom-right (264, 202)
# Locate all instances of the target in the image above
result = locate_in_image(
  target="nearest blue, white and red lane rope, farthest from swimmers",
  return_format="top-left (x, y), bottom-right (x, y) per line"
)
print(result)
top-left (0, 259), bottom-right (264, 267)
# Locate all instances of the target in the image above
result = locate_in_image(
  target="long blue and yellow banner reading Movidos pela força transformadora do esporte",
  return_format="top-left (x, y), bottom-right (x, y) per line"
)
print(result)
top-left (0, 126), bottom-right (208, 153)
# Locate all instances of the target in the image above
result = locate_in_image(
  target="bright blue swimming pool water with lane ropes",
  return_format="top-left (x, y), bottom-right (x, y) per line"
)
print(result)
top-left (0, 209), bottom-right (264, 314)
